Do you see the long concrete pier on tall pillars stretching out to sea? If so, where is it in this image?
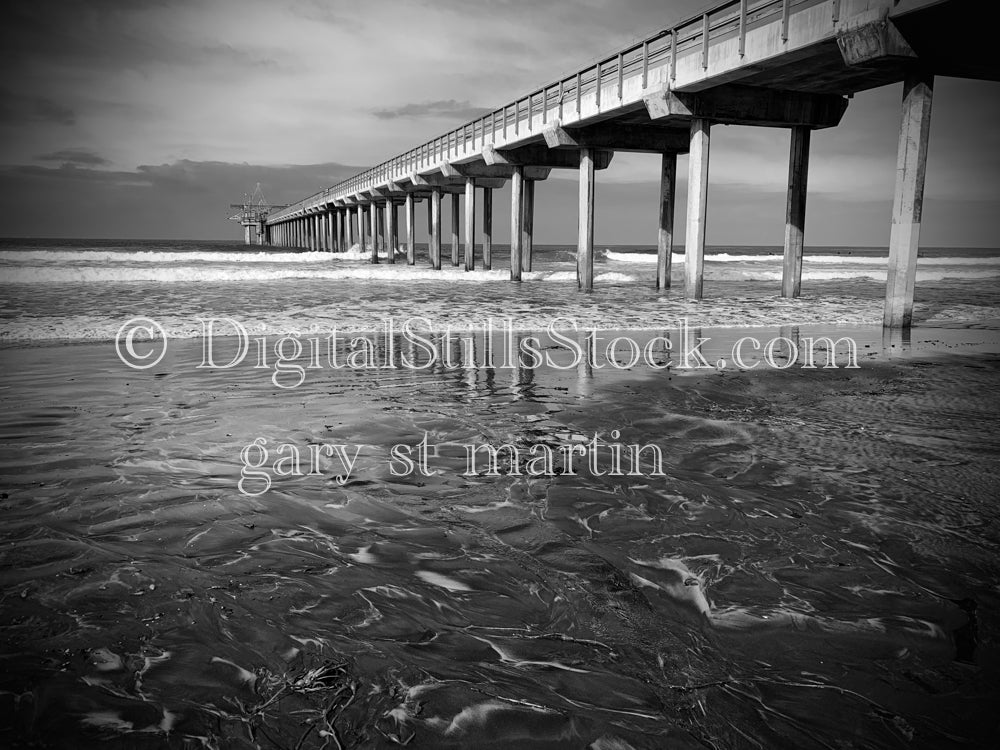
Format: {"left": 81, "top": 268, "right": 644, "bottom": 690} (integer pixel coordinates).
{"left": 259, "top": 0, "right": 1000, "bottom": 328}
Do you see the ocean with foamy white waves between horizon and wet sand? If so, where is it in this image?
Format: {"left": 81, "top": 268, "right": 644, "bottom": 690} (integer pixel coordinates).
{"left": 0, "top": 240, "right": 1000, "bottom": 343}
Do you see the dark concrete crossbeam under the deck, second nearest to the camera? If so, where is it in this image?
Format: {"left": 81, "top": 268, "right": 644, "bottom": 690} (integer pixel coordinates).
{"left": 643, "top": 84, "right": 847, "bottom": 129}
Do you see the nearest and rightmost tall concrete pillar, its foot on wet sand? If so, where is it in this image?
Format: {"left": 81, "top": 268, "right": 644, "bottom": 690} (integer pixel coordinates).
{"left": 882, "top": 70, "right": 934, "bottom": 328}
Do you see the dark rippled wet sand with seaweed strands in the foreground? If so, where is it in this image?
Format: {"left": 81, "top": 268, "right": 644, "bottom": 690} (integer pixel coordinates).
{"left": 0, "top": 326, "right": 1000, "bottom": 750}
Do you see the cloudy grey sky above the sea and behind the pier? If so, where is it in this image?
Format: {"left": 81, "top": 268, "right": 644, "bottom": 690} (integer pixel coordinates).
{"left": 0, "top": 0, "right": 1000, "bottom": 247}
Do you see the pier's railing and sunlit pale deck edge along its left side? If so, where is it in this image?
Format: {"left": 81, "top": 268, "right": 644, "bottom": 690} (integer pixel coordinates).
{"left": 268, "top": 0, "right": 841, "bottom": 223}
